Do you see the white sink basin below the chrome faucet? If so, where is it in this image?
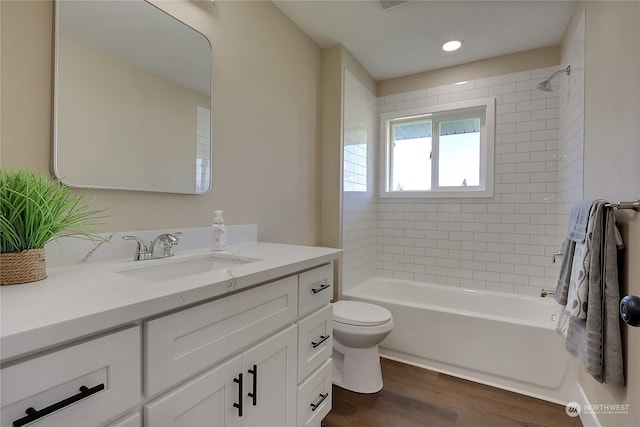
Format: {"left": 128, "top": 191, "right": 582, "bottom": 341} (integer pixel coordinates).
{"left": 118, "top": 254, "right": 259, "bottom": 282}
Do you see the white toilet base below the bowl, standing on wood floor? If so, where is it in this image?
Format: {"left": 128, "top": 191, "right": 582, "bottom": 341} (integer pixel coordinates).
{"left": 332, "top": 339, "right": 382, "bottom": 393}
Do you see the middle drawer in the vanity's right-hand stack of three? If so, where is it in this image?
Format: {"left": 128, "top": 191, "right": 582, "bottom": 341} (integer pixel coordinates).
{"left": 298, "top": 304, "right": 333, "bottom": 382}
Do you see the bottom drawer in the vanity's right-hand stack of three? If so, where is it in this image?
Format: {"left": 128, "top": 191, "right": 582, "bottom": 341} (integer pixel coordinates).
{"left": 297, "top": 359, "right": 333, "bottom": 427}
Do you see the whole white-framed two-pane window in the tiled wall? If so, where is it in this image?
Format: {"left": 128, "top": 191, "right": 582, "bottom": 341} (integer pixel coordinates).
{"left": 380, "top": 98, "right": 495, "bottom": 197}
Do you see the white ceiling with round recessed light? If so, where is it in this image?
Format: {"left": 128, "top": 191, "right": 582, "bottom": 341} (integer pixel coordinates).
{"left": 273, "top": 0, "right": 576, "bottom": 80}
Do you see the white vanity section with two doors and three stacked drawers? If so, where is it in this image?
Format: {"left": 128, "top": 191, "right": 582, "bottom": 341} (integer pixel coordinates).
{"left": 144, "top": 264, "right": 333, "bottom": 427}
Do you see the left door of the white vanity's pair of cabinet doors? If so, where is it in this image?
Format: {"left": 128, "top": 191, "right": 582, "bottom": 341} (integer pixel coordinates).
{"left": 144, "top": 356, "right": 242, "bottom": 427}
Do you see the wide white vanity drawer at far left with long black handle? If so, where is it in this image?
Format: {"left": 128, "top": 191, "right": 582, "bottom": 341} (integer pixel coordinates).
{"left": 0, "top": 327, "right": 140, "bottom": 427}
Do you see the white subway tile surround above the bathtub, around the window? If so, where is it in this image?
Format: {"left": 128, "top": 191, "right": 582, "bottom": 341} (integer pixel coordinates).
{"left": 343, "top": 66, "right": 583, "bottom": 295}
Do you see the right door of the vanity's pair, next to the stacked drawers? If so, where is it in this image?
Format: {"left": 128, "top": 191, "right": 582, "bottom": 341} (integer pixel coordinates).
{"left": 242, "top": 325, "right": 297, "bottom": 427}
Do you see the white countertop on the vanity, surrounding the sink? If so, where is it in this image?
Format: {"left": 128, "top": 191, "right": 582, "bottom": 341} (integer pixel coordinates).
{"left": 0, "top": 243, "right": 341, "bottom": 361}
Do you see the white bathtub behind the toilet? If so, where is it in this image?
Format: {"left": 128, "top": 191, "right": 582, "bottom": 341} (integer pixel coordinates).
{"left": 342, "top": 278, "right": 578, "bottom": 404}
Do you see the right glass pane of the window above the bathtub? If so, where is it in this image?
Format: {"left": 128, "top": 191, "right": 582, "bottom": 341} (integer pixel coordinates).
{"left": 438, "top": 118, "right": 480, "bottom": 187}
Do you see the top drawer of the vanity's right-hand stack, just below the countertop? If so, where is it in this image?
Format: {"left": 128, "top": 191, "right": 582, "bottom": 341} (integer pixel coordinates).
{"left": 298, "top": 264, "right": 333, "bottom": 317}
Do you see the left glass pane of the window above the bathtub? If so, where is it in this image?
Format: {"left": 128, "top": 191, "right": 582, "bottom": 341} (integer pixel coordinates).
{"left": 389, "top": 121, "right": 431, "bottom": 191}
